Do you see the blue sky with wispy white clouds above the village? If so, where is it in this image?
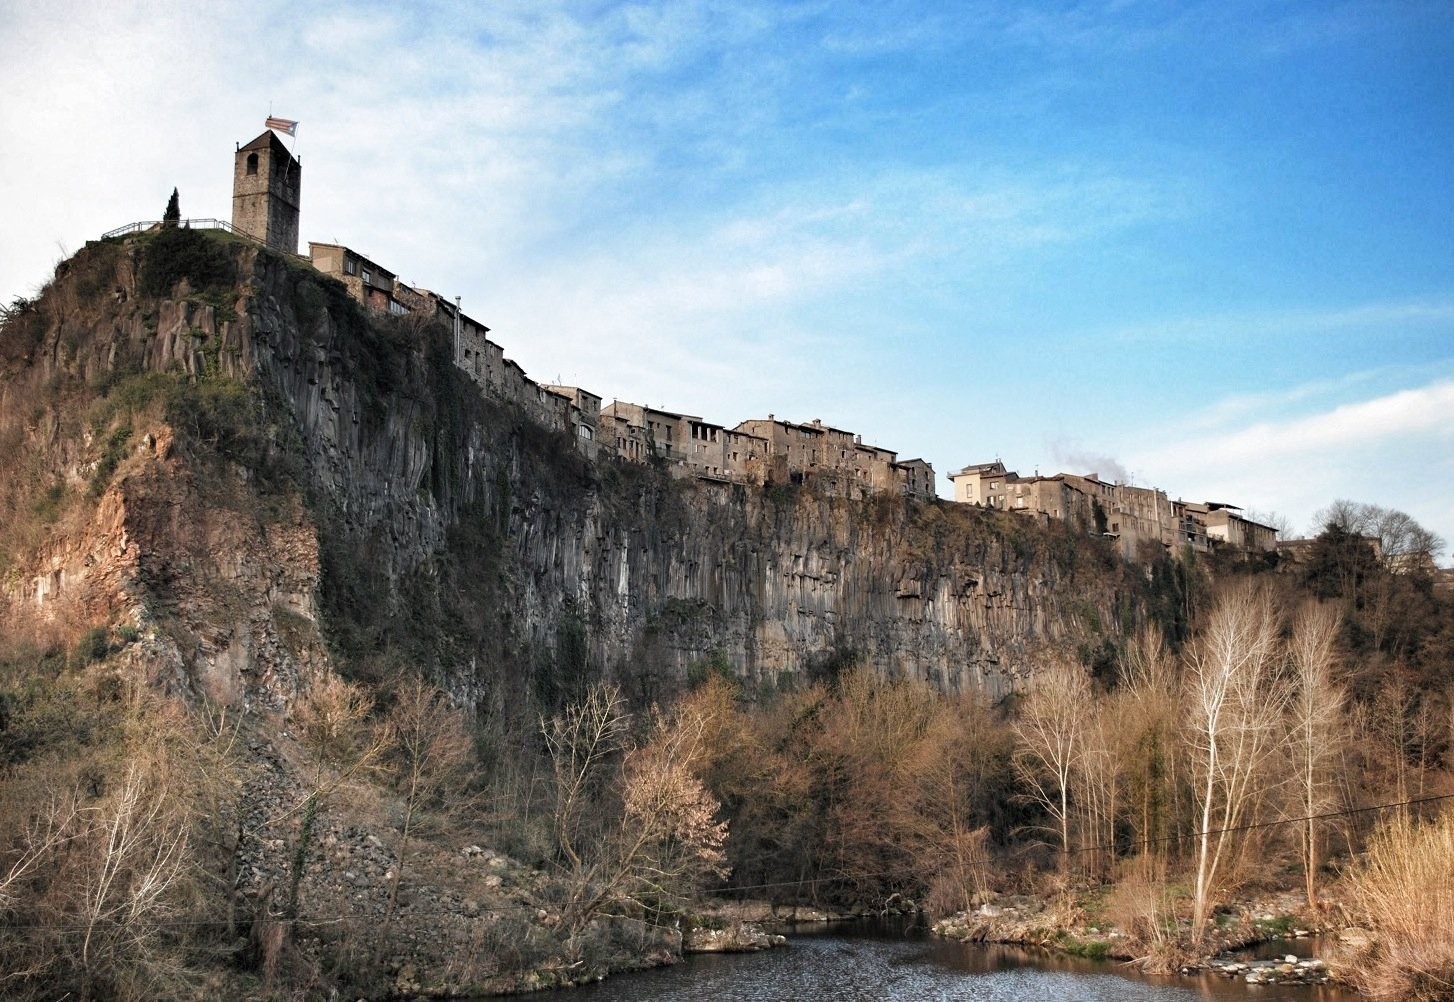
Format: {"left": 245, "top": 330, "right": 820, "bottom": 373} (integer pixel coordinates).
{"left": 8, "top": 0, "right": 1454, "bottom": 564}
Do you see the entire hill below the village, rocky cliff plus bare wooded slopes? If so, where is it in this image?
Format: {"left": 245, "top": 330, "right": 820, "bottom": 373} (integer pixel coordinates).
{"left": 0, "top": 230, "right": 1454, "bottom": 999}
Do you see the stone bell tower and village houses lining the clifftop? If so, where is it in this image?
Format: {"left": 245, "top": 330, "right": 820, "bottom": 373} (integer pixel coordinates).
{"left": 223, "top": 129, "right": 1277, "bottom": 560}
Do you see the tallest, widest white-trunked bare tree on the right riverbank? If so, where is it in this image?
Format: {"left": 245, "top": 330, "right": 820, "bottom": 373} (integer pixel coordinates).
{"left": 1188, "top": 585, "right": 1287, "bottom": 939}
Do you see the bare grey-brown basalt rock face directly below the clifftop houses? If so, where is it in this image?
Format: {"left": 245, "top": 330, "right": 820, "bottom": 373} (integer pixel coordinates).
{"left": 0, "top": 237, "right": 1144, "bottom": 707}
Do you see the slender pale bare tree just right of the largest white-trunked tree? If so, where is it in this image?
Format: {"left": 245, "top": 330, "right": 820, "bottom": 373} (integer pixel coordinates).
{"left": 1287, "top": 604, "right": 1346, "bottom": 907}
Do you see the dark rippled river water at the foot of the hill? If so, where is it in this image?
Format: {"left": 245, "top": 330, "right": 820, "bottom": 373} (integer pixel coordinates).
{"left": 529, "top": 929, "right": 1357, "bottom": 1002}
